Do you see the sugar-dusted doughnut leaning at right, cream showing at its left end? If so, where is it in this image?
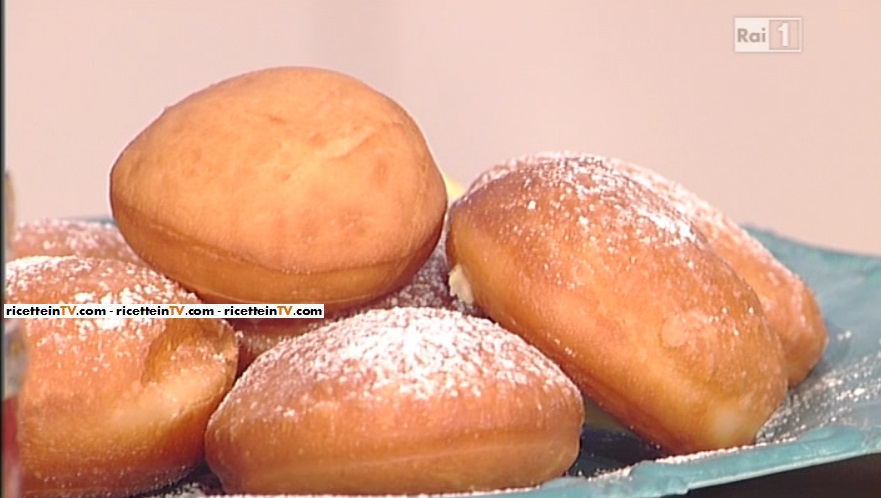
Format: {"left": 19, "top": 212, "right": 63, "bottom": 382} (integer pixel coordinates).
{"left": 447, "top": 156, "right": 786, "bottom": 453}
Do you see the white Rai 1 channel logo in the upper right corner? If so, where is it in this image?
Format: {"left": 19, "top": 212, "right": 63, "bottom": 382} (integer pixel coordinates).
{"left": 734, "top": 17, "right": 803, "bottom": 53}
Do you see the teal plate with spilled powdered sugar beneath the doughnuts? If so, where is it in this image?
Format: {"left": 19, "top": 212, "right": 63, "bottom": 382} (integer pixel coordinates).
{"left": 141, "top": 229, "right": 881, "bottom": 498}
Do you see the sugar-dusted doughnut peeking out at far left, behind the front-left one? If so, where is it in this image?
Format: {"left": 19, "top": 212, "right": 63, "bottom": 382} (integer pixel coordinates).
{"left": 10, "top": 218, "right": 144, "bottom": 265}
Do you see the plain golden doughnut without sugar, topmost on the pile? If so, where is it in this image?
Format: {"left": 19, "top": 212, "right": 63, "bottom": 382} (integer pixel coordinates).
{"left": 110, "top": 67, "right": 447, "bottom": 311}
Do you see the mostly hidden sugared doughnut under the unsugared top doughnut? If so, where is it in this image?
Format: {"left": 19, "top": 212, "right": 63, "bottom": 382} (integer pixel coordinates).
{"left": 229, "top": 246, "right": 484, "bottom": 370}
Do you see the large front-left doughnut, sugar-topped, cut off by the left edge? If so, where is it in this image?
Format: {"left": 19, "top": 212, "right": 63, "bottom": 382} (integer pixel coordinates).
{"left": 6, "top": 256, "right": 238, "bottom": 498}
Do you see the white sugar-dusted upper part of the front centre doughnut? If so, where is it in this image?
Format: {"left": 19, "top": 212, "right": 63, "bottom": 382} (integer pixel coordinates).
{"left": 230, "top": 308, "right": 577, "bottom": 408}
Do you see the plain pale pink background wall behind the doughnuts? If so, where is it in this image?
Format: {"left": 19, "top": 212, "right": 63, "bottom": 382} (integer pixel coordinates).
{"left": 4, "top": 0, "right": 881, "bottom": 255}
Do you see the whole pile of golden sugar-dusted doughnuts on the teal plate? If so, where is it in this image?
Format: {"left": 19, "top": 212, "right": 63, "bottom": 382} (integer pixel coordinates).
{"left": 6, "top": 67, "right": 826, "bottom": 497}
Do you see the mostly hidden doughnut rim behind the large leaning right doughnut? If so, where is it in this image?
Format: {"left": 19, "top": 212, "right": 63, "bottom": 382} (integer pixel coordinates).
{"left": 471, "top": 152, "right": 828, "bottom": 386}
